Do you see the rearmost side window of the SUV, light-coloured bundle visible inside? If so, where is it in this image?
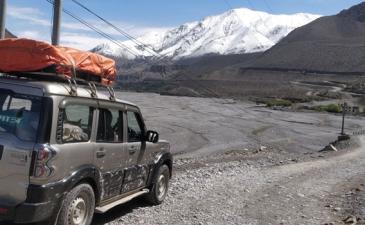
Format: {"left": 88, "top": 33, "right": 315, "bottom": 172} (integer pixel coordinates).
{"left": 62, "top": 105, "right": 94, "bottom": 143}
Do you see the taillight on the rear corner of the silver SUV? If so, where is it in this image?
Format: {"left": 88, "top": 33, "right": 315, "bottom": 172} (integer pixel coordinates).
{"left": 33, "top": 145, "right": 56, "bottom": 178}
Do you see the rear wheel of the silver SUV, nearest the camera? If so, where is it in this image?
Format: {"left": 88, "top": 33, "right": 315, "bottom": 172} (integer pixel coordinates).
{"left": 55, "top": 184, "right": 95, "bottom": 225}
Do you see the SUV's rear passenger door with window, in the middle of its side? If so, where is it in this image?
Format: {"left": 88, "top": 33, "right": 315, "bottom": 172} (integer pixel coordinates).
{"left": 95, "top": 105, "right": 126, "bottom": 200}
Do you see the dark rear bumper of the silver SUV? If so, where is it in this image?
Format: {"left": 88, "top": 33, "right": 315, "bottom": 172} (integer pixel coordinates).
{"left": 0, "top": 202, "right": 56, "bottom": 224}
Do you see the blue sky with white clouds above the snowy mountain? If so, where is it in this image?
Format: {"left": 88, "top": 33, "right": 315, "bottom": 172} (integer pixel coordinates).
{"left": 6, "top": 0, "right": 362, "bottom": 49}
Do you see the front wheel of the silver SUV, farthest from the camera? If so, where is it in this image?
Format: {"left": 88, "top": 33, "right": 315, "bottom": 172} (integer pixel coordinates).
{"left": 146, "top": 165, "right": 170, "bottom": 205}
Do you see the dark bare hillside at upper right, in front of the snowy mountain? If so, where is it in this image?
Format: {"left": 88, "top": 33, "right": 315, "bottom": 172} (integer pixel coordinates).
{"left": 247, "top": 2, "right": 365, "bottom": 72}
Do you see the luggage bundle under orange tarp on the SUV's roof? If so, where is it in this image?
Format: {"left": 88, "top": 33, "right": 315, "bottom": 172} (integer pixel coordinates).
{"left": 0, "top": 38, "right": 116, "bottom": 86}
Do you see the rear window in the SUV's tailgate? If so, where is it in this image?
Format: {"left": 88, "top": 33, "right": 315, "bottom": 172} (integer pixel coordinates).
{"left": 0, "top": 89, "right": 42, "bottom": 141}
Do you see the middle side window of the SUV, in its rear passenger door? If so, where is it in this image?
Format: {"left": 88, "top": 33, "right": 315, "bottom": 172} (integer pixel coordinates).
{"left": 96, "top": 109, "right": 123, "bottom": 142}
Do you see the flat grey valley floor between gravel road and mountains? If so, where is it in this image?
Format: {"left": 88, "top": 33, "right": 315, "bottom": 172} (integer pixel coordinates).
{"left": 117, "top": 92, "right": 365, "bottom": 158}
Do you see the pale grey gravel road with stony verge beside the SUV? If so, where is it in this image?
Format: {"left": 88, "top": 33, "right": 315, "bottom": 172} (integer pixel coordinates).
{"left": 93, "top": 138, "right": 365, "bottom": 225}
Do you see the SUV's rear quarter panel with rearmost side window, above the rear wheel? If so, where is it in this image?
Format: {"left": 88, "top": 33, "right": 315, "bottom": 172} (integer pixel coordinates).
{"left": 50, "top": 101, "right": 97, "bottom": 182}
